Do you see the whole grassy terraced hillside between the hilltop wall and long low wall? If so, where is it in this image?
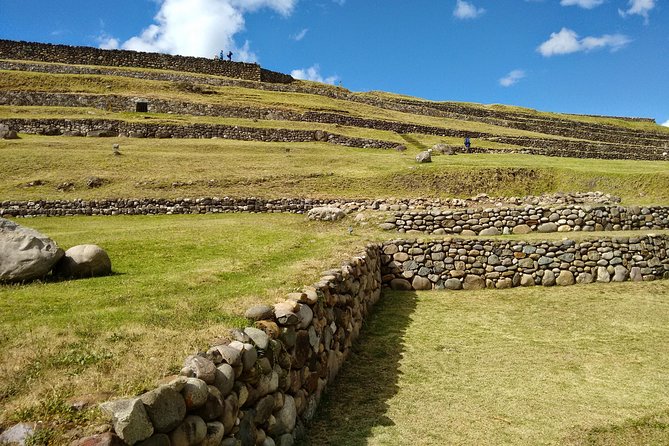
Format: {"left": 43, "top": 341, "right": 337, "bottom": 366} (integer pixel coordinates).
{"left": 0, "top": 52, "right": 669, "bottom": 203}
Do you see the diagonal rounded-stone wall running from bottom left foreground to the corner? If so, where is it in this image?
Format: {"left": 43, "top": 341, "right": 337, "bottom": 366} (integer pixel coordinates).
{"left": 97, "top": 245, "right": 381, "bottom": 446}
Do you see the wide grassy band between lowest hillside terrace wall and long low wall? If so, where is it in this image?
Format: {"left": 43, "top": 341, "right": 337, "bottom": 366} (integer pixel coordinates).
{"left": 0, "top": 135, "right": 669, "bottom": 204}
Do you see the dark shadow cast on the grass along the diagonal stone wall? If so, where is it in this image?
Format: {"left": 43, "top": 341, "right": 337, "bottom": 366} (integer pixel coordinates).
{"left": 298, "top": 292, "right": 417, "bottom": 446}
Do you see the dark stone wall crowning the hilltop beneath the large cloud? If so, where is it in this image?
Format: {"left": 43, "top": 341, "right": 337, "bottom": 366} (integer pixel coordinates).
{"left": 0, "top": 39, "right": 293, "bottom": 83}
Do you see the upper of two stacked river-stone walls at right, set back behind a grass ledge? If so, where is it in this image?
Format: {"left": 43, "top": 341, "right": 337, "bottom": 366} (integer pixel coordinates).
{"left": 381, "top": 205, "right": 669, "bottom": 236}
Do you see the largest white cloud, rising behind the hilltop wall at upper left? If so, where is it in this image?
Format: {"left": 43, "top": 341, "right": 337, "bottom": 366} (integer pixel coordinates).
{"left": 100, "top": 0, "right": 298, "bottom": 62}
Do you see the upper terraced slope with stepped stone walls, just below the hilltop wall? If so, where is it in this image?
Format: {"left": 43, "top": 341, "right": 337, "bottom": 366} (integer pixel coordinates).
{"left": 0, "top": 56, "right": 669, "bottom": 160}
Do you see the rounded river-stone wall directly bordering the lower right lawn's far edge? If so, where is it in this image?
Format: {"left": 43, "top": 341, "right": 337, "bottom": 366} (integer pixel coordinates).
{"left": 383, "top": 235, "right": 669, "bottom": 290}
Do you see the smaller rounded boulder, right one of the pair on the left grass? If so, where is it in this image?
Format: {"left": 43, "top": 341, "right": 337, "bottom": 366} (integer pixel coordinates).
{"left": 53, "top": 245, "right": 111, "bottom": 278}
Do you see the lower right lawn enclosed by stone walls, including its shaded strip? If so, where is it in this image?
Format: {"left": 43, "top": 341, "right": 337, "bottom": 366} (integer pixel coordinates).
{"left": 302, "top": 282, "right": 669, "bottom": 446}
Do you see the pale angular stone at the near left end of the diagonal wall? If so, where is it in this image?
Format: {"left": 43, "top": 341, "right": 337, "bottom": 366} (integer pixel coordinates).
{"left": 100, "top": 398, "right": 153, "bottom": 445}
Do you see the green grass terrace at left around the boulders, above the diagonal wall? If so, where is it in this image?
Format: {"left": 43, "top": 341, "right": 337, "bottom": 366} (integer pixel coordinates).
{"left": 0, "top": 214, "right": 368, "bottom": 440}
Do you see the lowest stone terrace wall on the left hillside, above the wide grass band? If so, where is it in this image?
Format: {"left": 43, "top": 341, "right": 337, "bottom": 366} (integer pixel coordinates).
{"left": 0, "top": 118, "right": 397, "bottom": 149}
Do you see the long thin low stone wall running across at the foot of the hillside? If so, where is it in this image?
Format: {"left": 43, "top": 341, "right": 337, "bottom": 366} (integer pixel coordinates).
{"left": 0, "top": 192, "right": 620, "bottom": 217}
